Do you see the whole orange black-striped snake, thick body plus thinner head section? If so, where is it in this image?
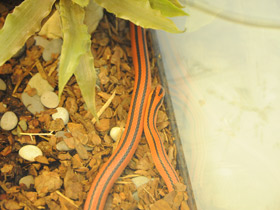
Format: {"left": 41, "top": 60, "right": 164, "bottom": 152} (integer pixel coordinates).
{"left": 84, "top": 23, "right": 178, "bottom": 210}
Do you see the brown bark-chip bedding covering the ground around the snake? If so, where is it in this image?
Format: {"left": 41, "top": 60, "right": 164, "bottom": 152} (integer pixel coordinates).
{"left": 0, "top": 2, "right": 189, "bottom": 210}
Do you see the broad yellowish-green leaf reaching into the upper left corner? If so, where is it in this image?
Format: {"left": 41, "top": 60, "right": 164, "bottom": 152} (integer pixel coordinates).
{"left": 0, "top": 0, "right": 55, "bottom": 66}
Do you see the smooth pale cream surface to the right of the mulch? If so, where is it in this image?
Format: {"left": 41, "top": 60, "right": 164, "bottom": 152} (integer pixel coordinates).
{"left": 155, "top": 0, "right": 280, "bottom": 210}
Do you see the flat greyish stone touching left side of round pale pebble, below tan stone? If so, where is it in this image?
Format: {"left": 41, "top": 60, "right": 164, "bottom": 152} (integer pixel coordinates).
{"left": 21, "top": 92, "right": 45, "bottom": 114}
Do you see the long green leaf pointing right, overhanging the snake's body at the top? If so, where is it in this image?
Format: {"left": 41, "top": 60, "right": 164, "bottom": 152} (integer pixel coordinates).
{"left": 95, "top": 0, "right": 183, "bottom": 33}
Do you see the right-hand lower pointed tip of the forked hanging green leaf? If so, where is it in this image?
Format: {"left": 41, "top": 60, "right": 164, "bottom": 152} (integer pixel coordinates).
{"left": 75, "top": 52, "right": 98, "bottom": 120}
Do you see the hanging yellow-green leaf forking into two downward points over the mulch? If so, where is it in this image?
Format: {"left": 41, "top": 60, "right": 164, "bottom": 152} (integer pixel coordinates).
{"left": 59, "top": 0, "right": 99, "bottom": 116}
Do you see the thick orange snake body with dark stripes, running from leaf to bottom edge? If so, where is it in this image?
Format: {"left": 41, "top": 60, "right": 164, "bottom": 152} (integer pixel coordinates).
{"left": 84, "top": 23, "right": 151, "bottom": 210}
